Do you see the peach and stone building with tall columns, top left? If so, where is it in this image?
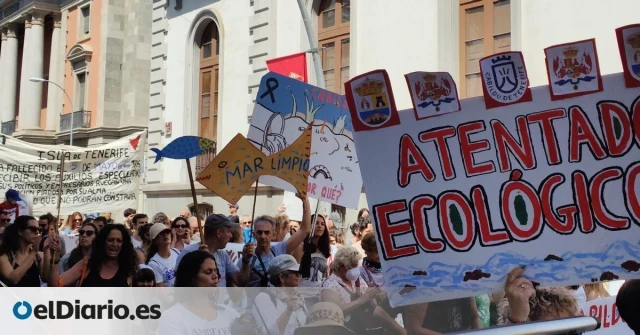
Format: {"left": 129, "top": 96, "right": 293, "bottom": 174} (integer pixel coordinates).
{"left": 0, "top": 0, "right": 152, "bottom": 146}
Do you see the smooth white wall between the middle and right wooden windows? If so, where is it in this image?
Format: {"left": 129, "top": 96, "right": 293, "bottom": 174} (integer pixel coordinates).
{"left": 351, "top": 0, "right": 440, "bottom": 109}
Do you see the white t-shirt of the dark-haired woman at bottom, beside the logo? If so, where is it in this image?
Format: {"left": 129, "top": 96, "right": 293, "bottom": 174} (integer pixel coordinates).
{"left": 156, "top": 303, "right": 238, "bottom": 335}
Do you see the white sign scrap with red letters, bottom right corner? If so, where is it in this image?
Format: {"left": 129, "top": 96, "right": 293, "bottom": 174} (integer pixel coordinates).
{"left": 580, "top": 296, "right": 634, "bottom": 335}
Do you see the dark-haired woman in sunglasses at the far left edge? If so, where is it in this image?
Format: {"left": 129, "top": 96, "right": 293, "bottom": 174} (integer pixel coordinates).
{"left": 0, "top": 215, "right": 48, "bottom": 287}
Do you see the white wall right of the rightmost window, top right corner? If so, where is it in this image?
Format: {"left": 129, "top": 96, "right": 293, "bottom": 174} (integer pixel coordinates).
{"left": 520, "top": 0, "right": 640, "bottom": 86}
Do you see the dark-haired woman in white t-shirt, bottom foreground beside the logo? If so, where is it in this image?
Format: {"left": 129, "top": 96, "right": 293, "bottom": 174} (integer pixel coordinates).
{"left": 156, "top": 250, "right": 238, "bottom": 335}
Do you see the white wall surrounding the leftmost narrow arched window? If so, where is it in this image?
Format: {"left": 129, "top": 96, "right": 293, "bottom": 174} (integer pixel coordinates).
{"left": 162, "top": 0, "right": 250, "bottom": 183}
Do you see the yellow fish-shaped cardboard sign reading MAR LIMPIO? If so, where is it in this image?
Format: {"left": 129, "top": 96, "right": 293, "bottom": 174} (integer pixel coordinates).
{"left": 196, "top": 125, "right": 311, "bottom": 204}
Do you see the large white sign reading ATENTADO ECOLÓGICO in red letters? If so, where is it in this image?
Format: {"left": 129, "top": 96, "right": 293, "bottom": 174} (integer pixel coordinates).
{"left": 352, "top": 73, "right": 640, "bottom": 306}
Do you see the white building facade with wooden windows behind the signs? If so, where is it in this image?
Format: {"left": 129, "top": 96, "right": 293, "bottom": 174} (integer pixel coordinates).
{"left": 143, "top": 0, "right": 640, "bottom": 223}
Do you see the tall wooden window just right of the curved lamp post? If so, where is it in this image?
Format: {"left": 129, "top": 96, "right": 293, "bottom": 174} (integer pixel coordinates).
{"left": 318, "top": 0, "right": 351, "bottom": 94}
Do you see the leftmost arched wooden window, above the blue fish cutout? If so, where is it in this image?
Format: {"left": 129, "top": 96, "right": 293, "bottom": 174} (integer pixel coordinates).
{"left": 198, "top": 21, "right": 220, "bottom": 142}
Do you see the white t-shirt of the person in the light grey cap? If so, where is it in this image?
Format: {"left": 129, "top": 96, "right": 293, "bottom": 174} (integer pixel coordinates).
{"left": 252, "top": 292, "right": 307, "bottom": 335}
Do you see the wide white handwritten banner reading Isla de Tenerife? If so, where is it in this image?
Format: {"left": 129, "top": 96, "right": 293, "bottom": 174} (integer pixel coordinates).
{"left": 0, "top": 132, "right": 146, "bottom": 215}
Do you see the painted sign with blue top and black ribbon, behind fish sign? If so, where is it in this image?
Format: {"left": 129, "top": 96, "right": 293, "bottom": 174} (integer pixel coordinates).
{"left": 247, "top": 73, "right": 362, "bottom": 208}
